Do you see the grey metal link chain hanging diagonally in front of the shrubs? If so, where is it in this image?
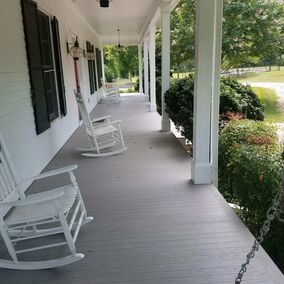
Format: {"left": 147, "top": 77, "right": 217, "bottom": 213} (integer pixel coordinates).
{"left": 235, "top": 169, "right": 284, "bottom": 284}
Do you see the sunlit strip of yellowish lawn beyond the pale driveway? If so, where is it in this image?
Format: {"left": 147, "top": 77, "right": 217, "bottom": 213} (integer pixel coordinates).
{"left": 237, "top": 70, "right": 284, "bottom": 83}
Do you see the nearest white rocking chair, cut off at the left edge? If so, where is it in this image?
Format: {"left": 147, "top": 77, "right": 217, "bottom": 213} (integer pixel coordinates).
{"left": 0, "top": 135, "right": 93, "bottom": 270}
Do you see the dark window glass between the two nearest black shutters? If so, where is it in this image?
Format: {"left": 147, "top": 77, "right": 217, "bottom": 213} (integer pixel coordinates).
{"left": 37, "top": 11, "right": 59, "bottom": 122}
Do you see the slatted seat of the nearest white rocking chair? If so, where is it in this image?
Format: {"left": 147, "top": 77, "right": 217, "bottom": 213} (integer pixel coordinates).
{"left": 5, "top": 185, "right": 77, "bottom": 225}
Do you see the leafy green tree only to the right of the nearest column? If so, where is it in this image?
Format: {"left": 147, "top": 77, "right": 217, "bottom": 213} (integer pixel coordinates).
{"left": 222, "top": 0, "right": 284, "bottom": 69}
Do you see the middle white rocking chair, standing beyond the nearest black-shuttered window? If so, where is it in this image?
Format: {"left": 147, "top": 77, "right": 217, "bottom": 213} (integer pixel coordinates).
{"left": 74, "top": 91, "right": 127, "bottom": 157}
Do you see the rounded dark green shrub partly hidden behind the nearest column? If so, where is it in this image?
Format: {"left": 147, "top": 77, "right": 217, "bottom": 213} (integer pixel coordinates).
{"left": 165, "top": 76, "right": 264, "bottom": 140}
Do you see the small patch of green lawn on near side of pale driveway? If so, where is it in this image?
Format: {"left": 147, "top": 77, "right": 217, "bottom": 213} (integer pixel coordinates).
{"left": 252, "top": 87, "right": 284, "bottom": 122}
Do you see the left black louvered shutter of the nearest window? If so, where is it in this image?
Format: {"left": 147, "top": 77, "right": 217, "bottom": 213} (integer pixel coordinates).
{"left": 21, "top": 0, "right": 50, "bottom": 134}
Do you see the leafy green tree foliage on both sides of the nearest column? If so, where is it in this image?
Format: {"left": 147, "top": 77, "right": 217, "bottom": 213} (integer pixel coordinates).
{"left": 171, "top": 0, "right": 284, "bottom": 71}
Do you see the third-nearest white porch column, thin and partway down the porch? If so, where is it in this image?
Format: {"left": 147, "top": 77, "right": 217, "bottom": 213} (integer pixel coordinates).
{"left": 149, "top": 25, "right": 157, "bottom": 111}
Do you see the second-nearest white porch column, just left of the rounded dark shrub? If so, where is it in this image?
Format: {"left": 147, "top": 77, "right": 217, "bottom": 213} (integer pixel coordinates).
{"left": 161, "top": 2, "right": 171, "bottom": 131}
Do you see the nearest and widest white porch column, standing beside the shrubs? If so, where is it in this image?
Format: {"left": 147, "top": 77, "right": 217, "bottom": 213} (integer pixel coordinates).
{"left": 192, "top": 0, "right": 223, "bottom": 184}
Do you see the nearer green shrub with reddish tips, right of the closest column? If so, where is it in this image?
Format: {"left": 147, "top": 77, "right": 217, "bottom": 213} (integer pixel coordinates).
{"left": 219, "top": 120, "right": 281, "bottom": 204}
